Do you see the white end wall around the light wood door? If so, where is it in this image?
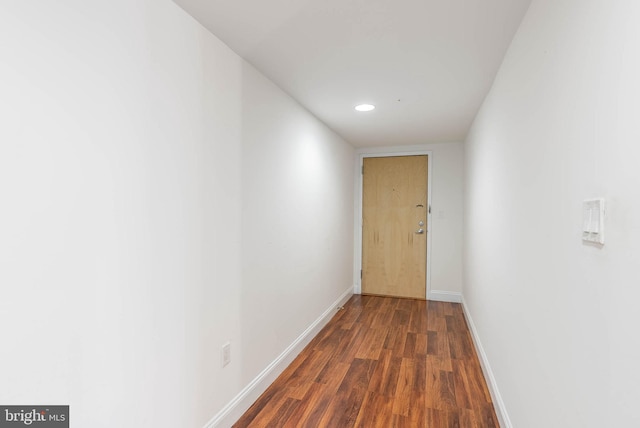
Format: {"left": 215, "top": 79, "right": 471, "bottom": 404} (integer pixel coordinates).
{"left": 354, "top": 143, "right": 464, "bottom": 300}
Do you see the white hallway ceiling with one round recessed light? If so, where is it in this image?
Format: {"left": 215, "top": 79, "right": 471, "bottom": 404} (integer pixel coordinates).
{"left": 174, "top": 0, "right": 531, "bottom": 147}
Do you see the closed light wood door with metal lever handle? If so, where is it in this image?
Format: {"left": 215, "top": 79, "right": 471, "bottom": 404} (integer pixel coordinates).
{"left": 362, "top": 155, "right": 428, "bottom": 299}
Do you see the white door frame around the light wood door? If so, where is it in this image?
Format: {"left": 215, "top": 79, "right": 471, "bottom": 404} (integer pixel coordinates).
{"left": 353, "top": 148, "right": 433, "bottom": 299}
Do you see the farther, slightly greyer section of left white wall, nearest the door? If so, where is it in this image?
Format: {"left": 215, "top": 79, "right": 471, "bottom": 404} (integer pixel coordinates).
{"left": 241, "top": 65, "right": 355, "bottom": 382}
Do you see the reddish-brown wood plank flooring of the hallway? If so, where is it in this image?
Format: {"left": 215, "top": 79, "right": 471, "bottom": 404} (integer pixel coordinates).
{"left": 234, "top": 295, "right": 498, "bottom": 428}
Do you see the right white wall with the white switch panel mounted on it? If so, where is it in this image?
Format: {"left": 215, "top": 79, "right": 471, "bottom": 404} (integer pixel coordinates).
{"left": 463, "top": 0, "right": 640, "bottom": 428}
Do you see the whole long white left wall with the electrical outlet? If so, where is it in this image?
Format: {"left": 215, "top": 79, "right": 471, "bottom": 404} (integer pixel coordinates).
{"left": 0, "top": 0, "right": 354, "bottom": 428}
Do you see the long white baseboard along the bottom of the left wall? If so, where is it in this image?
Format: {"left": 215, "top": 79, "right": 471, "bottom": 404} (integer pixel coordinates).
{"left": 204, "top": 286, "right": 353, "bottom": 428}
